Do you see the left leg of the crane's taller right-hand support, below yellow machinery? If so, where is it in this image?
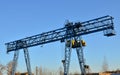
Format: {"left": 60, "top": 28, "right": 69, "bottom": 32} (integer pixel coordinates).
{"left": 63, "top": 40, "right": 72, "bottom": 75}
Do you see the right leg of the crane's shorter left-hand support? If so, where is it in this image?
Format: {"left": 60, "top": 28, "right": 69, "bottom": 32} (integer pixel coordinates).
{"left": 24, "top": 48, "right": 32, "bottom": 75}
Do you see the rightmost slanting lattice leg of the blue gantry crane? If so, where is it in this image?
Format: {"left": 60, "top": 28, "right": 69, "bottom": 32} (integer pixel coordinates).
{"left": 76, "top": 37, "right": 86, "bottom": 75}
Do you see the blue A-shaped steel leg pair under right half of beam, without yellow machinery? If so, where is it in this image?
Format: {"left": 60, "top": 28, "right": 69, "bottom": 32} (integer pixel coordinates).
{"left": 63, "top": 37, "right": 86, "bottom": 75}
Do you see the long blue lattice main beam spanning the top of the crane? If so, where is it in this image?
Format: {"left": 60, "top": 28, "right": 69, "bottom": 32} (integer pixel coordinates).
{"left": 6, "top": 15, "right": 115, "bottom": 53}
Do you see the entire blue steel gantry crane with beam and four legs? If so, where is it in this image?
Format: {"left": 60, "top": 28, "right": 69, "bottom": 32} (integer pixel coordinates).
{"left": 5, "top": 15, "right": 115, "bottom": 75}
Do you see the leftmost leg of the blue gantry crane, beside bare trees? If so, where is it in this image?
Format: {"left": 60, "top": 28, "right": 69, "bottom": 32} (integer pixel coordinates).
{"left": 11, "top": 50, "right": 19, "bottom": 75}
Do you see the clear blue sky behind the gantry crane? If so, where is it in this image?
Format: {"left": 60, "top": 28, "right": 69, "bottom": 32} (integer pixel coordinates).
{"left": 0, "top": 0, "right": 120, "bottom": 72}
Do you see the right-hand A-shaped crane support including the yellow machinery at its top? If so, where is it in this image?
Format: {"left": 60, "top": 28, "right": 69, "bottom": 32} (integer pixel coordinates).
{"left": 62, "top": 37, "right": 86, "bottom": 75}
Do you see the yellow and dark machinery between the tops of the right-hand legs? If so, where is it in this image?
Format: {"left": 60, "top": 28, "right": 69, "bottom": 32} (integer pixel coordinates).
{"left": 66, "top": 40, "right": 86, "bottom": 48}
